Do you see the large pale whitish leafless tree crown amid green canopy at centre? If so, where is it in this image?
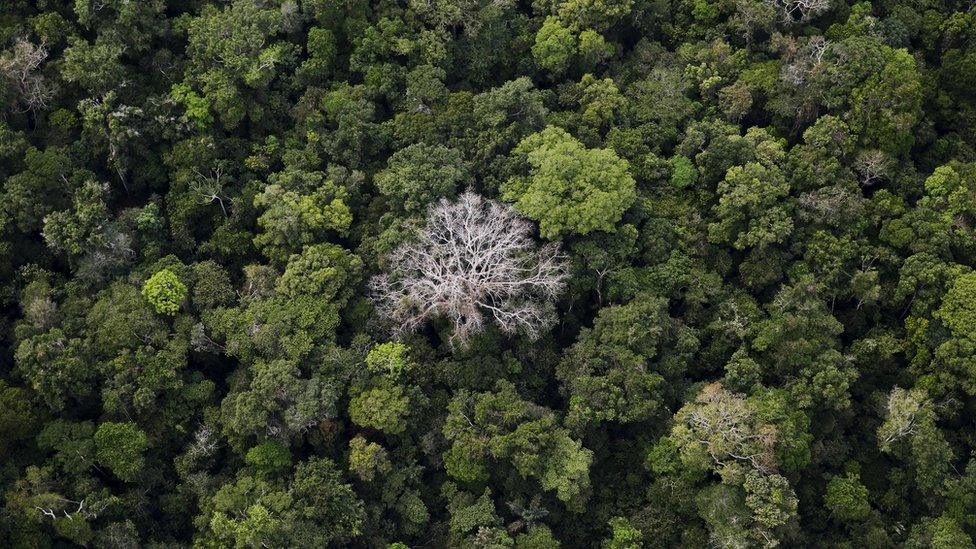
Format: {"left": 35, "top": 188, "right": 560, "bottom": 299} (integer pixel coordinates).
{"left": 371, "top": 192, "right": 568, "bottom": 345}
